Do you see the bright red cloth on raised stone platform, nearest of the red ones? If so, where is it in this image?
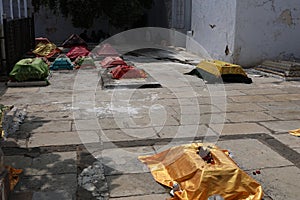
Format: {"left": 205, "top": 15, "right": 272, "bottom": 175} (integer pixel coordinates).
{"left": 111, "top": 65, "right": 147, "bottom": 79}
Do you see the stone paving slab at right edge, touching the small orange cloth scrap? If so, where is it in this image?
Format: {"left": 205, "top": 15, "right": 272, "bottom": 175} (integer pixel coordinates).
{"left": 260, "top": 120, "right": 300, "bottom": 133}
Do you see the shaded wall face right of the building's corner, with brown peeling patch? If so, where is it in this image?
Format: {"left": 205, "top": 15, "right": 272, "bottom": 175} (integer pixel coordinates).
{"left": 233, "top": 0, "right": 300, "bottom": 66}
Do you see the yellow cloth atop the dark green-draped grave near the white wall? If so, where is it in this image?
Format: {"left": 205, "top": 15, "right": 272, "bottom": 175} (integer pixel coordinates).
{"left": 197, "top": 60, "right": 247, "bottom": 77}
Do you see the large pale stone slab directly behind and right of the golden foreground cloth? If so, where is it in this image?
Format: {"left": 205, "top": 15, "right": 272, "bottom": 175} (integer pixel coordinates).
{"left": 217, "top": 139, "right": 293, "bottom": 170}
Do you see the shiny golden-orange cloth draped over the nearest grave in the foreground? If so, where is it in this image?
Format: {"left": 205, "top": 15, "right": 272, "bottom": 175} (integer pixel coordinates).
{"left": 139, "top": 143, "right": 263, "bottom": 200}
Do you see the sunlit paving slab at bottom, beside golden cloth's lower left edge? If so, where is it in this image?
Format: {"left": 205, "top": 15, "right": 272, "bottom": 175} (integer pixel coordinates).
{"left": 107, "top": 173, "right": 168, "bottom": 198}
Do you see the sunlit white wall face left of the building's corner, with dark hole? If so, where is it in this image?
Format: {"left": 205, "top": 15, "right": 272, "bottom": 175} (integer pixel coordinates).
{"left": 187, "top": 0, "right": 236, "bottom": 62}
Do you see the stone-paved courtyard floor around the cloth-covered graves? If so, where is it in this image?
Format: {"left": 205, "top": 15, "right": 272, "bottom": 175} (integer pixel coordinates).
{"left": 0, "top": 48, "right": 300, "bottom": 200}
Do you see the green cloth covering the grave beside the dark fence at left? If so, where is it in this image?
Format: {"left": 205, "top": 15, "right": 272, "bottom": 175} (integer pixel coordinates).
{"left": 9, "top": 58, "right": 49, "bottom": 82}
